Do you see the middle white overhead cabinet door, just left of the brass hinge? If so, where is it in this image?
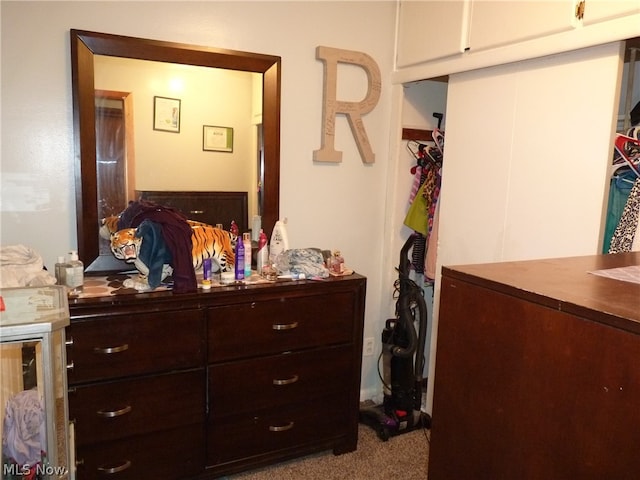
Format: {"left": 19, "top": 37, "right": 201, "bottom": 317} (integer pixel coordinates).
{"left": 469, "top": 0, "right": 578, "bottom": 53}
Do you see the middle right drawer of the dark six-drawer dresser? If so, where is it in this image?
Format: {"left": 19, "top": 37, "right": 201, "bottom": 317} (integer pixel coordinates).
{"left": 208, "top": 345, "right": 353, "bottom": 418}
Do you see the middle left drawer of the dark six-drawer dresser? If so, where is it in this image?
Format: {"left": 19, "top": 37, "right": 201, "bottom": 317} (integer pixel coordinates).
{"left": 69, "top": 369, "right": 205, "bottom": 445}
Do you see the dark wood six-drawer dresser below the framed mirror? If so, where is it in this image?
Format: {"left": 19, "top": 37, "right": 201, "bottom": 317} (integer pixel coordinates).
{"left": 67, "top": 274, "right": 366, "bottom": 480}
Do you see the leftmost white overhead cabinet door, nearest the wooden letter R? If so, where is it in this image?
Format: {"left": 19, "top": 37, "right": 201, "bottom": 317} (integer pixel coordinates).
{"left": 396, "top": 0, "right": 470, "bottom": 68}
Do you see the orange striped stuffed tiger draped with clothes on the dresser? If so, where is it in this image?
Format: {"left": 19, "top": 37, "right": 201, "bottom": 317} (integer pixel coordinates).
{"left": 100, "top": 215, "right": 238, "bottom": 291}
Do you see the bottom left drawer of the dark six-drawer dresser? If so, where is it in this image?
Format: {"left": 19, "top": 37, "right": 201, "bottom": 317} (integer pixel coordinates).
{"left": 76, "top": 425, "right": 205, "bottom": 480}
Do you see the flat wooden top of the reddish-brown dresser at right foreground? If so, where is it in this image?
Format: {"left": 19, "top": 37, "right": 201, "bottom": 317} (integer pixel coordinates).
{"left": 442, "top": 252, "right": 640, "bottom": 334}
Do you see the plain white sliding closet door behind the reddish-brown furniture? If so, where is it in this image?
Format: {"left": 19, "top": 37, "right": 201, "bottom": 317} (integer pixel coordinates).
{"left": 427, "top": 43, "right": 621, "bottom": 414}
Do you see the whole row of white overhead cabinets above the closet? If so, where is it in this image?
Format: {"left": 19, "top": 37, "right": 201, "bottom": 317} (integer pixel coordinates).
{"left": 396, "top": 0, "right": 640, "bottom": 78}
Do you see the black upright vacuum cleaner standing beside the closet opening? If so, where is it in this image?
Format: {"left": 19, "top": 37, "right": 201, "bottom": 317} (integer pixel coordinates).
{"left": 360, "top": 234, "right": 431, "bottom": 441}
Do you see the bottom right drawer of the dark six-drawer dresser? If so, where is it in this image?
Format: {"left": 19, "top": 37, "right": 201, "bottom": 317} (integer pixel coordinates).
{"left": 207, "top": 395, "right": 353, "bottom": 465}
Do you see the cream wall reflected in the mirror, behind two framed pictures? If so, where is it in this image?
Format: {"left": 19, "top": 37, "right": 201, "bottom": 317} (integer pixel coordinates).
{"left": 94, "top": 55, "right": 262, "bottom": 195}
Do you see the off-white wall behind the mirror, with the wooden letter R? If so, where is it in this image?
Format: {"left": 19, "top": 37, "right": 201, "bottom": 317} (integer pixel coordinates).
{"left": 0, "top": 1, "right": 395, "bottom": 400}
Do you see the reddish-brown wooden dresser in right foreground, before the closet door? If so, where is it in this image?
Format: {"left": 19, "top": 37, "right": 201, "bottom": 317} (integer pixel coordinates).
{"left": 429, "top": 252, "right": 640, "bottom": 480}
